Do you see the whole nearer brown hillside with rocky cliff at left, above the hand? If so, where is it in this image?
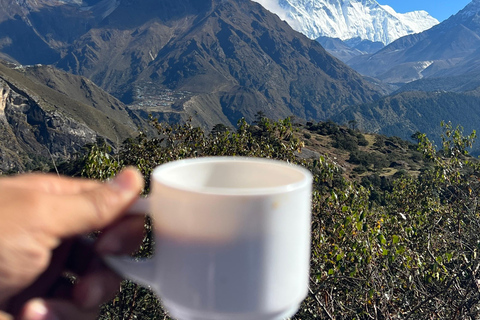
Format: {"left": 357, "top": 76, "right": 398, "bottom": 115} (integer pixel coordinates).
{"left": 0, "top": 63, "right": 141, "bottom": 172}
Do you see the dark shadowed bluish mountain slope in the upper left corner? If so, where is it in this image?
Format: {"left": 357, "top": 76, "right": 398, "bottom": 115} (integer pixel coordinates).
{"left": 0, "top": 0, "right": 119, "bottom": 65}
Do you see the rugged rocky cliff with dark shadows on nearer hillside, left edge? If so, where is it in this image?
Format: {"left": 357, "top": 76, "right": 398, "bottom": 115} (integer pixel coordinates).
{"left": 0, "top": 80, "right": 97, "bottom": 171}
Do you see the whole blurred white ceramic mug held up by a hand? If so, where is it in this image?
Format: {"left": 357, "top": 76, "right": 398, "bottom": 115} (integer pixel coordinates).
{"left": 106, "top": 157, "right": 312, "bottom": 320}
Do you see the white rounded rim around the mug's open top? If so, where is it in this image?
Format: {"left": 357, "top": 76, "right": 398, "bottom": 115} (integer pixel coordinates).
{"left": 151, "top": 156, "right": 313, "bottom": 196}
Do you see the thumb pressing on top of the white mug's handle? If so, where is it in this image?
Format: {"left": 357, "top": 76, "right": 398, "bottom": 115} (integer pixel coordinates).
{"left": 50, "top": 168, "right": 143, "bottom": 238}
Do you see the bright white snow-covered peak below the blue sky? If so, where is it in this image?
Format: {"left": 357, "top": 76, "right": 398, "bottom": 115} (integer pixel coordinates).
{"left": 256, "top": 0, "right": 439, "bottom": 45}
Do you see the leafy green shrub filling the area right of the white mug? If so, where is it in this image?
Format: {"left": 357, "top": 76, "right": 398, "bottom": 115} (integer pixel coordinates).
{"left": 299, "top": 123, "right": 480, "bottom": 319}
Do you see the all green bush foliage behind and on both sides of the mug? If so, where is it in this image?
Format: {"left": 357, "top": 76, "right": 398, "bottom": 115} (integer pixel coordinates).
{"left": 77, "top": 117, "right": 480, "bottom": 320}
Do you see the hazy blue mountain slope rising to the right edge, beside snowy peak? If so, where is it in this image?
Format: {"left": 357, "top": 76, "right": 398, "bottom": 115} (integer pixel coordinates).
{"left": 348, "top": 0, "right": 480, "bottom": 83}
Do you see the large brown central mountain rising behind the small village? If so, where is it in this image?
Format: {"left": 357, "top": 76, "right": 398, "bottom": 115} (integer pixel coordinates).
{"left": 51, "top": 0, "right": 379, "bottom": 127}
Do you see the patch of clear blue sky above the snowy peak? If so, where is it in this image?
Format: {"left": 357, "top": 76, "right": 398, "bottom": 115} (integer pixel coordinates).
{"left": 377, "top": 0, "right": 471, "bottom": 22}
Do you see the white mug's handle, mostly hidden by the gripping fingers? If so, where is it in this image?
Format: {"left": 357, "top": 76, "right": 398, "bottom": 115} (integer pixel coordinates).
{"left": 103, "top": 198, "right": 156, "bottom": 289}
